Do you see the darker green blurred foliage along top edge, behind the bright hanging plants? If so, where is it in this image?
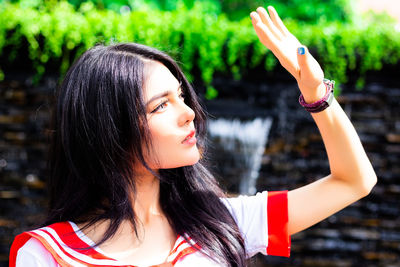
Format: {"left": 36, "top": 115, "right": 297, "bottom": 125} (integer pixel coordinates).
{"left": 47, "top": 0, "right": 354, "bottom": 23}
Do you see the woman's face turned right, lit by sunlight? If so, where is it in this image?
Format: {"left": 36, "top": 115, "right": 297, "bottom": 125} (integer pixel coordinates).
{"left": 144, "top": 62, "right": 200, "bottom": 169}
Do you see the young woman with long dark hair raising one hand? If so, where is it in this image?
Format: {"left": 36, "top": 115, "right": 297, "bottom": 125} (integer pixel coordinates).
{"left": 10, "top": 7, "right": 377, "bottom": 267}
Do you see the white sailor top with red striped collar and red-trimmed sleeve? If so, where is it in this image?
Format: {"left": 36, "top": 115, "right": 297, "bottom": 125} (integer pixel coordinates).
{"left": 9, "top": 191, "right": 290, "bottom": 267}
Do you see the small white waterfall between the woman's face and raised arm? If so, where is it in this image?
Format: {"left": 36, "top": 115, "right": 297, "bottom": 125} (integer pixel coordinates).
{"left": 209, "top": 118, "right": 272, "bottom": 195}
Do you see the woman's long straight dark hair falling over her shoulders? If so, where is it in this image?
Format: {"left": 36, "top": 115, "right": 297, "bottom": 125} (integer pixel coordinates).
{"left": 44, "top": 43, "right": 246, "bottom": 266}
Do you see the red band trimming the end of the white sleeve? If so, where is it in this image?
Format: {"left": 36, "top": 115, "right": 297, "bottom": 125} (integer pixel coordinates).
{"left": 267, "top": 191, "right": 291, "bottom": 257}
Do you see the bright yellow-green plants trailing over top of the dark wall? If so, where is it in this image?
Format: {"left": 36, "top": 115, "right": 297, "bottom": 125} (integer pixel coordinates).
{"left": 0, "top": 0, "right": 400, "bottom": 98}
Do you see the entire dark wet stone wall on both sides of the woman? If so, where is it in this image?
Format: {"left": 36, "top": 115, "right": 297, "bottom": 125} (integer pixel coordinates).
{"left": 0, "top": 69, "right": 400, "bottom": 266}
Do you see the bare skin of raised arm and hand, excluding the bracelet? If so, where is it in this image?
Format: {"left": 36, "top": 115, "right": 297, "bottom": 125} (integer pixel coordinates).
{"left": 250, "top": 6, "right": 377, "bottom": 235}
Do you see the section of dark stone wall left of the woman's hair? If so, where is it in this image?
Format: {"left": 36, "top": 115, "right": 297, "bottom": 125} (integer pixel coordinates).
{"left": 0, "top": 73, "right": 56, "bottom": 266}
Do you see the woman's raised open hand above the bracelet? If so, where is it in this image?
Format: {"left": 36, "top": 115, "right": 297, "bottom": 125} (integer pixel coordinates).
{"left": 250, "top": 6, "right": 326, "bottom": 103}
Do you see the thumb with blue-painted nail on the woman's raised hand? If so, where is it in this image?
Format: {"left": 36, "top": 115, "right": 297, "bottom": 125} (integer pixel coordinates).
{"left": 297, "top": 46, "right": 324, "bottom": 84}
